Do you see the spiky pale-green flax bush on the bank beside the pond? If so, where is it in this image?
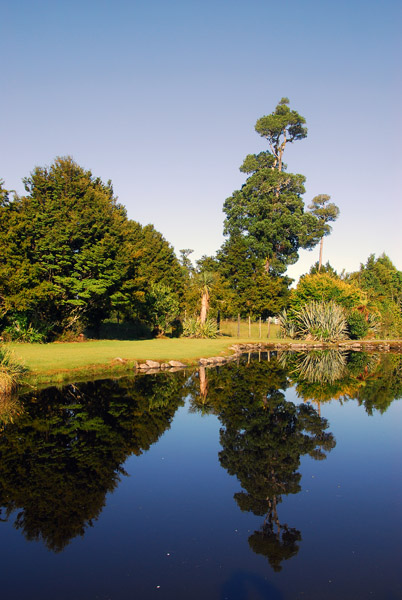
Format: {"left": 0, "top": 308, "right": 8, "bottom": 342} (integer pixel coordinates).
{"left": 280, "top": 301, "right": 348, "bottom": 341}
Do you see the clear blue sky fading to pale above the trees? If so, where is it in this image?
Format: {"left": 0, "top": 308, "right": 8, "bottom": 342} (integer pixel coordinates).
{"left": 0, "top": 0, "right": 402, "bottom": 277}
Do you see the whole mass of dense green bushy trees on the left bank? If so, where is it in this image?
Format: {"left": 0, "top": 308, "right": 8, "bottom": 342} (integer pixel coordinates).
{"left": 0, "top": 157, "right": 185, "bottom": 341}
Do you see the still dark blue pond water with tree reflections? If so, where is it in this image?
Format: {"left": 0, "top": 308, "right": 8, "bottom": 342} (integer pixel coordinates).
{"left": 0, "top": 353, "right": 402, "bottom": 600}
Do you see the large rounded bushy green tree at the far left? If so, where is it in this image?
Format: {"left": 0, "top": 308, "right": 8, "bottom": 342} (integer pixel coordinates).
{"left": 0, "top": 157, "right": 134, "bottom": 332}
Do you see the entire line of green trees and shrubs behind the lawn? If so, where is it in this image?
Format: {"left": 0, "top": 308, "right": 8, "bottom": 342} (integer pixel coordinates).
{"left": 0, "top": 98, "right": 402, "bottom": 341}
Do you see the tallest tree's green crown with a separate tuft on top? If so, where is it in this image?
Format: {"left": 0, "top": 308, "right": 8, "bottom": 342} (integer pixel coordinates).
{"left": 223, "top": 98, "right": 322, "bottom": 275}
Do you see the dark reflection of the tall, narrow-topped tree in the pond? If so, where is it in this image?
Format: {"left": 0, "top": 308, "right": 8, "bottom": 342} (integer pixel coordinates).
{"left": 204, "top": 359, "right": 335, "bottom": 571}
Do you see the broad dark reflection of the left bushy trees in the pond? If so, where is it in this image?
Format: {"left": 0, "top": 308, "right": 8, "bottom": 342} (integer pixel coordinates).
{"left": 0, "top": 374, "right": 187, "bottom": 551}
